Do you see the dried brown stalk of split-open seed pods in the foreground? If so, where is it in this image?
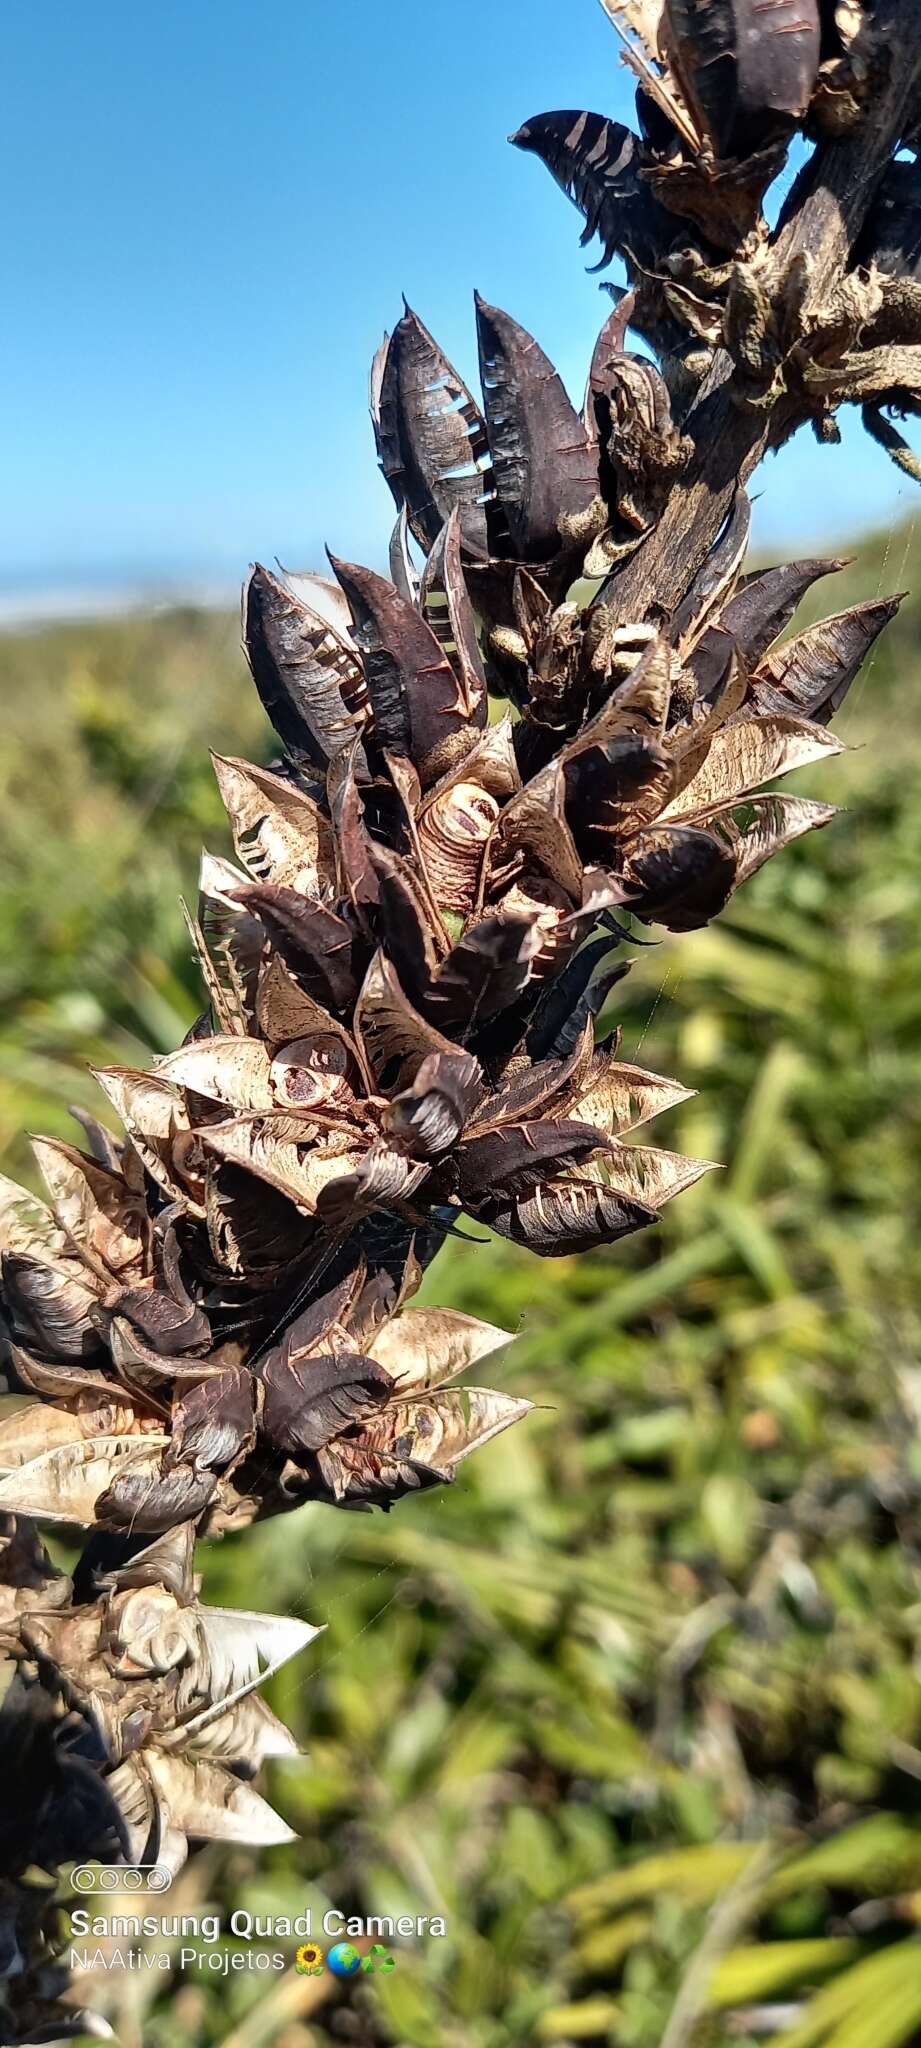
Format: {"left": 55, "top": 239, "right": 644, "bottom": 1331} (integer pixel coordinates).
{"left": 0, "top": 0, "right": 921, "bottom": 2040}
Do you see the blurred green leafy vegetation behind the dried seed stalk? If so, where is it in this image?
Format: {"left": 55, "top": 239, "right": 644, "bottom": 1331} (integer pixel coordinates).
{"left": 0, "top": 530, "right": 921, "bottom": 2048}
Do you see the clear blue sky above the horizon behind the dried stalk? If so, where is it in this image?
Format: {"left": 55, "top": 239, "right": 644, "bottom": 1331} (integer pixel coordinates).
{"left": 0, "top": 0, "right": 915, "bottom": 592}
